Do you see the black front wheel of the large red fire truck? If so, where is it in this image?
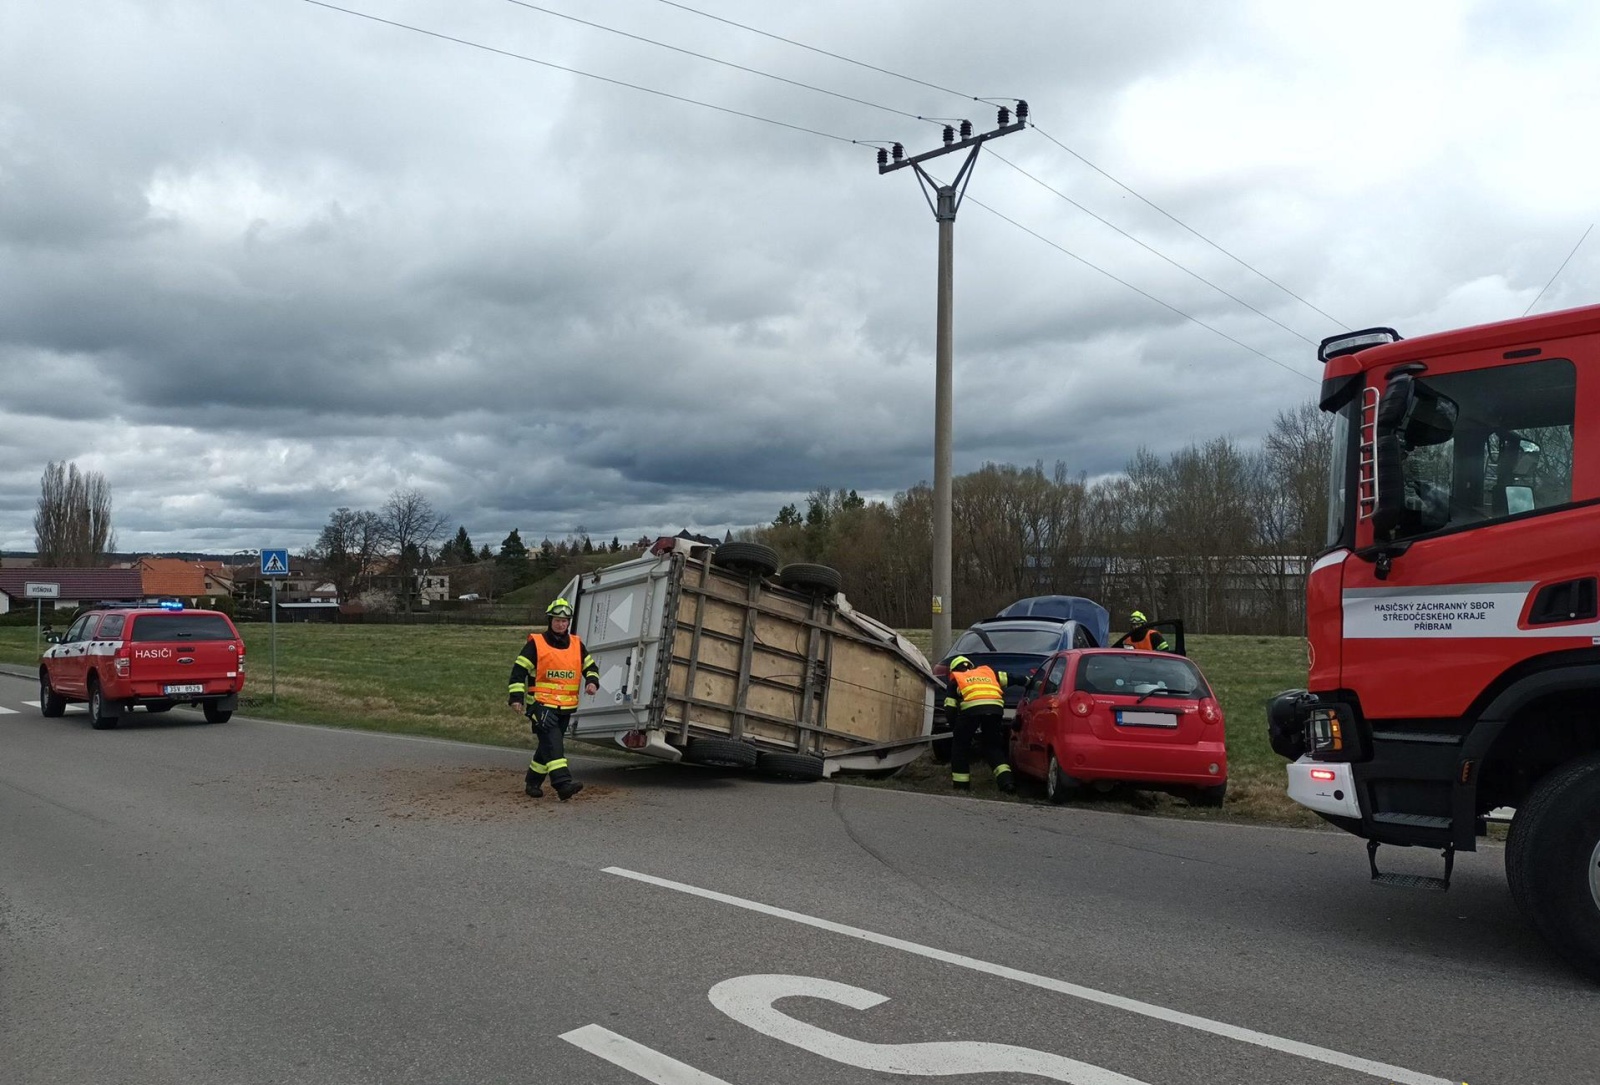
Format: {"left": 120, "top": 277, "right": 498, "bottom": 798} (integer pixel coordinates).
{"left": 1506, "top": 755, "right": 1600, "bottom": 979}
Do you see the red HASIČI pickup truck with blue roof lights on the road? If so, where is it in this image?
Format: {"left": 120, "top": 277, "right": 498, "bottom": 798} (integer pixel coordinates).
{"left": 38, "top": 603, "right": 245, "bottom": 731}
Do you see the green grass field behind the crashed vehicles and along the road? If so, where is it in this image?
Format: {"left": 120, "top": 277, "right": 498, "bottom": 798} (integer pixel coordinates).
{"left": 0, "top": 624, "right": 1322, "bottom": 826}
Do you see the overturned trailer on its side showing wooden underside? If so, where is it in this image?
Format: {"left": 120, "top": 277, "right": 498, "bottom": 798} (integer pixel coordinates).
{"left": 563, "top": 538, "right": 938, "bottom": 779}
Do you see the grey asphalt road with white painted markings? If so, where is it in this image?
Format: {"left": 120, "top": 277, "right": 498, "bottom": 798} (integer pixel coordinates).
{"left": 0, "top": 662, "right": 1600, "bottom": 1085}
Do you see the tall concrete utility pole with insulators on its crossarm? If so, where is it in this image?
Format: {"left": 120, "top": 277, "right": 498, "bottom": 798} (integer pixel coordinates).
{"left": 878, "top": 101, "right": 1027, "bottom": 659}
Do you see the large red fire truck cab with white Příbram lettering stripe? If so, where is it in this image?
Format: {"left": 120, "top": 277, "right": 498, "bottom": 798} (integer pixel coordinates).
{"left": 1267, "top": 306, "right": 1600, "bottom": 979}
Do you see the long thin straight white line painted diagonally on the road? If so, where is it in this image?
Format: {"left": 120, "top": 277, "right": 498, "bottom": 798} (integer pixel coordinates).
{"left": 603, "top": 866, "right": 1459, "bottom": 1085}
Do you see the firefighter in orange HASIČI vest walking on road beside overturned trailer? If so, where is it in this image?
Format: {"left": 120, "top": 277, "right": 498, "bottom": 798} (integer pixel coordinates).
{"left": 509, "top": 599, "right": 600, "bottom": 802}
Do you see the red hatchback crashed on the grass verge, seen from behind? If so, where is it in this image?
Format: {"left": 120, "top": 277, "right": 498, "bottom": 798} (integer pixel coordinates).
{"left": 1011, "top": 648, "right": 1227, "bottom": 807}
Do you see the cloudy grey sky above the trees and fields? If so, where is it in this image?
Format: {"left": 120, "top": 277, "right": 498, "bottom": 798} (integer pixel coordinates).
{"left": 0, "top": 0, "right": 1600, "bottom": 552}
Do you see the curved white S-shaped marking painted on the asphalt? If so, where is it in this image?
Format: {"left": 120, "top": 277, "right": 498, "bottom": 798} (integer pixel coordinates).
{"left": 709, "top": 976, "right": 1147, "bottom": 1085}
